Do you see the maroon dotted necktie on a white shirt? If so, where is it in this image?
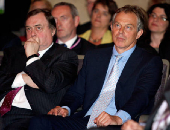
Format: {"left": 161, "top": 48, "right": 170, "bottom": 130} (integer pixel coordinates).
{"left": 0, "top": 87, "right": 22, "bottom": 116}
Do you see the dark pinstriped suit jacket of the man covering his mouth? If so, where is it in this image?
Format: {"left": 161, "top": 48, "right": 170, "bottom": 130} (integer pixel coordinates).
{"left": 0, "top": 44, "right": 78, "bottom": 114}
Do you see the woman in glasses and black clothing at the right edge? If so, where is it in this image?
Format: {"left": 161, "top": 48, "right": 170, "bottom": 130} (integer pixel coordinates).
{"left": 137, "top": 4, "right": 170, "bottom": 61}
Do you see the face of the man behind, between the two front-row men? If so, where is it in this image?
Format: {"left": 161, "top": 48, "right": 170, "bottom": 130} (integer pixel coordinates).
{"left": 52, "top": 5, "right": 79, "bottom": 42}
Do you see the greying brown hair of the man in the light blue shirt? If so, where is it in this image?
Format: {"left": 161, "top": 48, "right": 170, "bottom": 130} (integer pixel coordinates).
{"left": 112, "top": 5, "right": 148, "bottom": 31}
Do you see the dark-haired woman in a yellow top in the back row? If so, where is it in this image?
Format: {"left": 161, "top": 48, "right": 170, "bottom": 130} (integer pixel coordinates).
{"left": 80, "top": 0, "right": 117, "bottom": 46}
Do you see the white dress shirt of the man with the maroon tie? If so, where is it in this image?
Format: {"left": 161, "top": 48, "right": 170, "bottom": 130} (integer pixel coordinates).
{"left": 0, "top": 43, "right": 53, "bottom": 109}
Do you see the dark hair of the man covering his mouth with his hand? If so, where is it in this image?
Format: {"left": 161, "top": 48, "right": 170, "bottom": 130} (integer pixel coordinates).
{"left": 26, "top": 9, "right": 56, "bottom": 30}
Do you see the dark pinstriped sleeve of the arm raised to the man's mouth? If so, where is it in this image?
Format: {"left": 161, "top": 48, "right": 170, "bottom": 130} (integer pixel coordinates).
{"left": 24, "top": 50, "right": 78, "bottom": 93}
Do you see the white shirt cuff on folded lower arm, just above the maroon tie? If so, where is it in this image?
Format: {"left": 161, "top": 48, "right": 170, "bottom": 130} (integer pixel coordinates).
{"left": 11, "top": 72, "right": 25, "bottom": 88}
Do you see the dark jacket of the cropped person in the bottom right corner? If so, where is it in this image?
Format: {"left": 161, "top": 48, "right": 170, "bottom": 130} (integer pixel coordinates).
{"left": 145, "top": 80, "right": 170, "bottom": 130}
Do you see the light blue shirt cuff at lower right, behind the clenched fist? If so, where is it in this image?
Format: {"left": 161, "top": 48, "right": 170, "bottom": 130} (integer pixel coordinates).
{"left": 115, "top": 110, "right": 131, "bottom": 124}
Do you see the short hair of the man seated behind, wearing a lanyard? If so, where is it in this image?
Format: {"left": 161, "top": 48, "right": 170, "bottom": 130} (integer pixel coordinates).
{"left": 52, "top": 2, "right": 79, "bottom": 18}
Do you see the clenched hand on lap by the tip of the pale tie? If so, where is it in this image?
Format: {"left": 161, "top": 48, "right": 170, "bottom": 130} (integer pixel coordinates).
{"left": 94, "top": 111, "right": 122, "bottom": 127}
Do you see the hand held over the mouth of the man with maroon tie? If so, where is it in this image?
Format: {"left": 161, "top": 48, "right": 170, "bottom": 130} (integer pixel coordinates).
{"left": 24, "top": 36, "right": 40, "bottom": 57}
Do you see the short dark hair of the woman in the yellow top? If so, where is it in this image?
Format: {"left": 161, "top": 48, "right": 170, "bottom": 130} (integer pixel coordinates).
{"left": 92, "top": 0, "right": 118, "bottom": 21}
